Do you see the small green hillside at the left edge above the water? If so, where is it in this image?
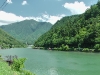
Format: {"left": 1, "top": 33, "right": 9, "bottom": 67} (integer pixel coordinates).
{"left": 0, "top": 29, "right": 24, "bottom": 49}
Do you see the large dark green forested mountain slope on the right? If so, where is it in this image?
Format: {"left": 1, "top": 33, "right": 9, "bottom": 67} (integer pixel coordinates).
{"left": 34, "top": 1, "right": 100, "bottom": 51}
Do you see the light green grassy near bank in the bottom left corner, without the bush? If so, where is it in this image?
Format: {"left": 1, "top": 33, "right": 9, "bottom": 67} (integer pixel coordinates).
{"left": 0, "top": 56, "right": 35, "bottom": 75}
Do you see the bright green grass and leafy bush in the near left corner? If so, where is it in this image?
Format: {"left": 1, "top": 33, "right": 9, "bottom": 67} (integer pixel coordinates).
{"left": 0, "top": 55, "right": 35, "bottom": 75}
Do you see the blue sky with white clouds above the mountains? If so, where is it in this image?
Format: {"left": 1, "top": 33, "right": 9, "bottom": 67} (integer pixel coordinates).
{"left": 0, "top": 0, "right": 98, "bottom": 25}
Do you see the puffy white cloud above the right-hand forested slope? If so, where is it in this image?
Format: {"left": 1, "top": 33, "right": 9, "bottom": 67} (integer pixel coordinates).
{"left": 63, "top": 1, "right": 90, "bottom": 14}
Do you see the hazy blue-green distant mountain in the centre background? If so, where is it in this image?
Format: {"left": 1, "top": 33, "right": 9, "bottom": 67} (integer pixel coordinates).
{"left": 1, "top": 20, "right": 52, "bottom": 44}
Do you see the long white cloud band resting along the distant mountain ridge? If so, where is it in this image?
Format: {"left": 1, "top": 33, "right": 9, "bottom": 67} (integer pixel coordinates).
{"left": 0, "top": 11, "right": 65, "bottom": 25}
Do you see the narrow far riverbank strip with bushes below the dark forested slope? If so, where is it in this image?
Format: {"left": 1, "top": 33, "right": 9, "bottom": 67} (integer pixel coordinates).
{"left": 32, "top": 46, "right": 100, "bottom": 53}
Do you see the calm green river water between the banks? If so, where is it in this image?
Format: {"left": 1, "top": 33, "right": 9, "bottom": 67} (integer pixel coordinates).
{"left": 0, "top": 48, "right": 100, "bottom": 75}
